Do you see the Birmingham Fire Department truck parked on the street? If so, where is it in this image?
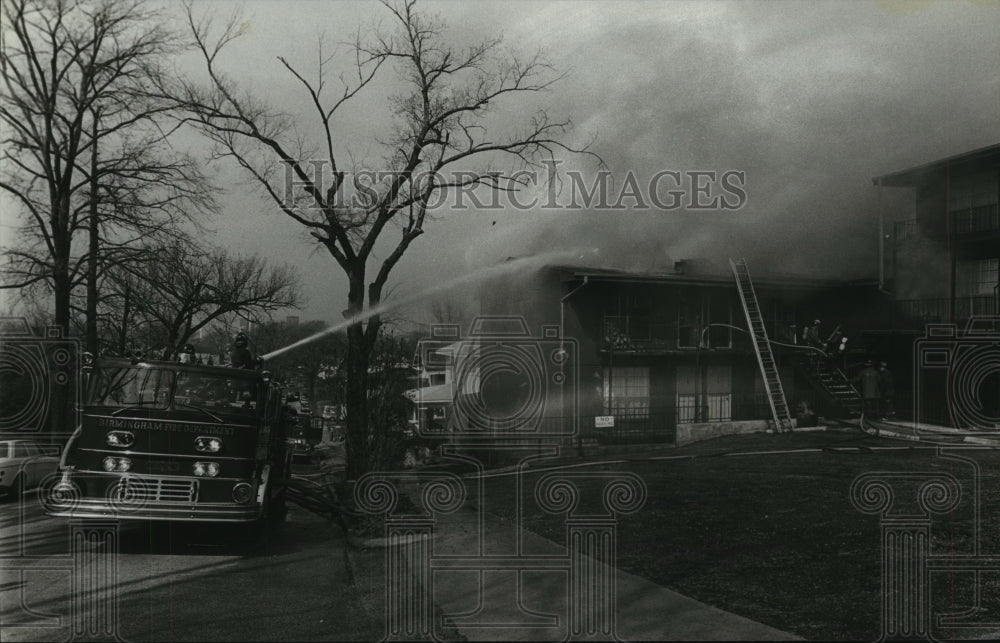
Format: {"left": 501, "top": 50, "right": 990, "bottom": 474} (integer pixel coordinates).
{"left": 43, "top": 354, "right": 291, "bottom": 528}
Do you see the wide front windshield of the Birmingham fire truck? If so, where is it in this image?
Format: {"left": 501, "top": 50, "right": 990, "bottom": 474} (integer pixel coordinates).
{"left": 89, "top": 366, "right": 257, "bottom": 412}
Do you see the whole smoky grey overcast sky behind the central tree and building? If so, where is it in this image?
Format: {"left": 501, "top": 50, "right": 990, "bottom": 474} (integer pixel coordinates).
{"left": 1, "top": 0, "right": 1000, "bottom": 330}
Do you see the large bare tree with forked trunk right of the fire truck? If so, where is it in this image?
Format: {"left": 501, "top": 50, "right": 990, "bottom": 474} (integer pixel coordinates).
{"left": 171, "top": 1, "right": 585, "bottom": 478}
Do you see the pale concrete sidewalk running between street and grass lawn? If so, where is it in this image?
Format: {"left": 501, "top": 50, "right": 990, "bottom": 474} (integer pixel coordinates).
{"left": 349, "top": 488, "right": 799, "bottom": 641}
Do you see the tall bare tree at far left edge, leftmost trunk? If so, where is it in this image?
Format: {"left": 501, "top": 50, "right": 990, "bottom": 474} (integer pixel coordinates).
{"left": 0, "top": 0, "right": 178, "bottom": 328}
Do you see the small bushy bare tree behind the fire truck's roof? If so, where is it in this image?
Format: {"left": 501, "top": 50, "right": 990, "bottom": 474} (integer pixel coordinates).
{"left": 115, "top": 242, "right": 300, "bottom": 357}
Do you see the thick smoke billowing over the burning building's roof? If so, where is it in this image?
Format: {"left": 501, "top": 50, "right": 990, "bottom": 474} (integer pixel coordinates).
{"left": 426, "top": 2, "right": 1000, "bottom": 300}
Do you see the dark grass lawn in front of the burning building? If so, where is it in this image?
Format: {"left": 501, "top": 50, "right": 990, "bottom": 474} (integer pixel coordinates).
{"left": 472, "top": 431, "right": 1000, "bottom": 640}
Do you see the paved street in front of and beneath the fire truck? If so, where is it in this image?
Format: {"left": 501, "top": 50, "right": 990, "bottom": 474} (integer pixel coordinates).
{"left": 0, "top": 499, "right": 378, "bottom": 641}
